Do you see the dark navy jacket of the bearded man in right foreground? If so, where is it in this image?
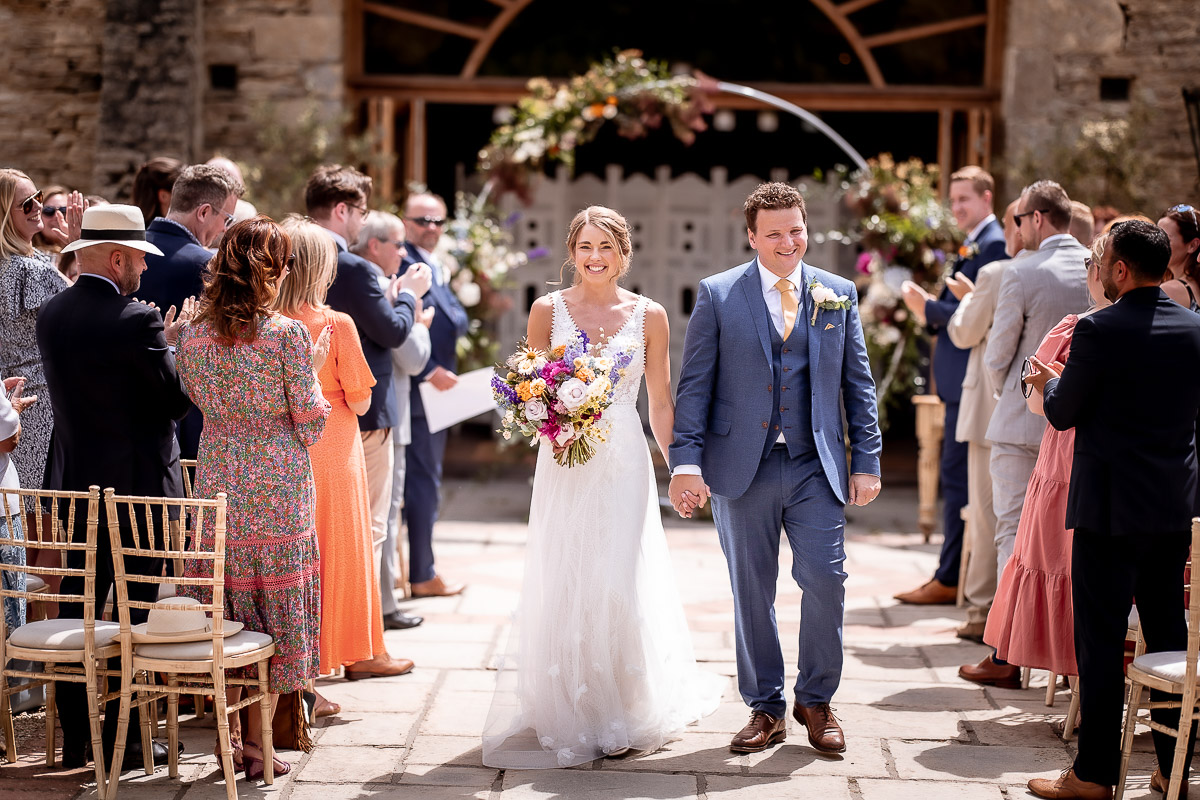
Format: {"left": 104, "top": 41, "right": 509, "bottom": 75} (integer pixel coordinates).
{"left": 1043, "top": 287, "right": 1200, "bottom": 536}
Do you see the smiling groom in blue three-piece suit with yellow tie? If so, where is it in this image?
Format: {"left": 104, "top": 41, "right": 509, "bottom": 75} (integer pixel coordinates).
{"left": 670, "top": 182, "right": 881, "bottom": 753}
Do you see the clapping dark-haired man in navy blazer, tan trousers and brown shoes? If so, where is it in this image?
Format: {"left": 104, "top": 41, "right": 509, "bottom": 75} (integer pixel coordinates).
{"left": 305, "top": 164, "right": 431, "bottom": 679}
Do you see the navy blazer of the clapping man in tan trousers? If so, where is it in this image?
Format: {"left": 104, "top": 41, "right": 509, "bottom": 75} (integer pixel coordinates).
{"left": 325, "top": 240, "right": 416, "bottom": 431}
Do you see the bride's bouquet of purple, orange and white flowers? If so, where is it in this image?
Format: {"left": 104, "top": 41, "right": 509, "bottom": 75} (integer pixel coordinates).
{"left": 492, "top": 331, "right": 632, "bottom": 467}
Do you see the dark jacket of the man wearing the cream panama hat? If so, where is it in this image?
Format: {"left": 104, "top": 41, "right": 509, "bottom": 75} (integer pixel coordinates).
{"left": 37, "top": 275, "right": 191, "bottom": 498}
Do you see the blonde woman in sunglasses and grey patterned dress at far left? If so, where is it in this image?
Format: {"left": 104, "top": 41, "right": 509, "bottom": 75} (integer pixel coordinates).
{"left": 0, "top": 169, "right": 68, "bottom": 510}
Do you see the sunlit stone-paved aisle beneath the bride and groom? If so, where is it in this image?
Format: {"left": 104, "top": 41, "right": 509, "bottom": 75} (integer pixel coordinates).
{"left": 0, "top": 482, "right": 1158, "bottom": 800}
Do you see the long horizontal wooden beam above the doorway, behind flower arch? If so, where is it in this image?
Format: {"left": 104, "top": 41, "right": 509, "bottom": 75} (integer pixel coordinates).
{"left": 348, "top": 76, "right": 1000, "bottom": 112}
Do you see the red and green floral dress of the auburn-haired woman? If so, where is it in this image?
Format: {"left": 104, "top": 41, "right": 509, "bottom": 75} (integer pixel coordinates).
{"left": 176, "top": 314, "right": 330, "bottom": 693}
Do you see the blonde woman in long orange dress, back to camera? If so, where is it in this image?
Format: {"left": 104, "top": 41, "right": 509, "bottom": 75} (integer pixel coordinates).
{"left": 276, "top": 217, "right": 388, "bottom": 716}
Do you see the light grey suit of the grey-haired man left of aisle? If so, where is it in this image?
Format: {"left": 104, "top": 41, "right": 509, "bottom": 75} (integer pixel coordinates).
{"left": 379, "top": 325, "right": 430, "bottom": 616}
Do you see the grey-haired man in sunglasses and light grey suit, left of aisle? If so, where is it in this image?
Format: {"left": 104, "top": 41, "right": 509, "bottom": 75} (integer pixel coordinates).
{"left": 350, "top": 211, "right": 434, "bottom": 630}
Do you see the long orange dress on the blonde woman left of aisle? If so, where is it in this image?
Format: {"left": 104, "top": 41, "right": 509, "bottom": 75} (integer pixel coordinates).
{"left": 283, "top": 306, "right": 386, "bottom": 674}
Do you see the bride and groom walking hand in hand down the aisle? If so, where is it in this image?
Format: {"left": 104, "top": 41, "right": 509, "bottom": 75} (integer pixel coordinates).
{"left": 484, "top": 182, "right": 881, "bottom": 769}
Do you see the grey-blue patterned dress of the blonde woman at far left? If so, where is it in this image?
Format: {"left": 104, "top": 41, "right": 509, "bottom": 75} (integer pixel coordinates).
{"left": 0, "top": 249, "right": 68, "bottom": 501}
